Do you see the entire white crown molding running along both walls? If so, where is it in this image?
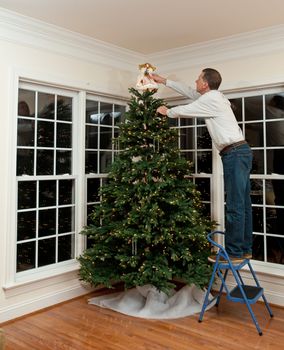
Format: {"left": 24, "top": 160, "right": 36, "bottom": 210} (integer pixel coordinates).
{"left": 0, "top": 8, "right": 284, "bottom": 74}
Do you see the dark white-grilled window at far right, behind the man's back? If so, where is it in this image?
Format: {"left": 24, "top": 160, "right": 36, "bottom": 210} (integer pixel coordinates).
{"left": 231, "top": 89, "right": 284, "bottom": 264}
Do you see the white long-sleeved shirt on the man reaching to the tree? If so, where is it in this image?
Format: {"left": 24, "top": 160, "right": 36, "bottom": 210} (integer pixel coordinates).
{"left": 166, "top": 80, "right": 244, "bottom": 151}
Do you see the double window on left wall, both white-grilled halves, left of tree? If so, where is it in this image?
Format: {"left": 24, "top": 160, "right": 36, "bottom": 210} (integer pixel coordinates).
{"left": 13, "top": 82, "right": 126, "bottom": 280}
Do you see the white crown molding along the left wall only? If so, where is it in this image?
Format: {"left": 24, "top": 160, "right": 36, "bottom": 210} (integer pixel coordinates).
{"left": 0, "top": 8, "right": 146, "bottom": 71}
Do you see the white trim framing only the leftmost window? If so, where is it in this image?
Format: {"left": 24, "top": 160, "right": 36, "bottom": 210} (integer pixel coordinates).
{"left": 3, "top": 69, "right": 86, "bottom": 291}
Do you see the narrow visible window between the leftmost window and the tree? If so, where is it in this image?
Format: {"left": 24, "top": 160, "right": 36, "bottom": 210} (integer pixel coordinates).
{"left": 85, "top": 95, "right": 126, "bottom": 238}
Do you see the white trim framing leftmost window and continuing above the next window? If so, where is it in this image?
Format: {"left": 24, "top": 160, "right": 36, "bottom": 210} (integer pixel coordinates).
{"left": 2, "top": 67, "right": 129, "bottom": 292}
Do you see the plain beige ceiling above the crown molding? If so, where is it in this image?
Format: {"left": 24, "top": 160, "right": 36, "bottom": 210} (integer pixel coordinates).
{"left": 0, "top": 0, "right": 284, "bottom": 55}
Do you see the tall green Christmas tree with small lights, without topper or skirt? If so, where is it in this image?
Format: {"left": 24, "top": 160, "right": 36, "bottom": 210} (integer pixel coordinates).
{"left": 78, "top": 88, "right": 212, "bottom": 293}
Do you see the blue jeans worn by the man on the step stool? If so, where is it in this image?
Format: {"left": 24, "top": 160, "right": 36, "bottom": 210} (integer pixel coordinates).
{"left": 221, "top": 144, "right": 253, "bottom": 257}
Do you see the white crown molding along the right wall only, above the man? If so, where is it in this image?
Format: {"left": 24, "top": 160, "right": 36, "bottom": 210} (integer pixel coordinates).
{"left": 147, "top": 25, "right": 284, "bottom": 73}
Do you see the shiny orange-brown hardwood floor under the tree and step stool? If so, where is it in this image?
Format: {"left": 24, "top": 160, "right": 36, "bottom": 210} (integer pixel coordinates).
{"left": 1, "top": 284, "right": 284, "bottom": 350}
